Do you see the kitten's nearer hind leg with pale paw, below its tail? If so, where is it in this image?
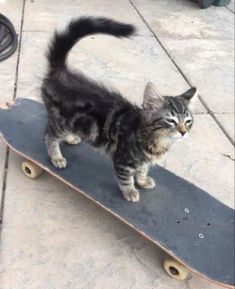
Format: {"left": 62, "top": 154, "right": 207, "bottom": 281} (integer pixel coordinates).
{"left": 45, "top": 134, "right": 67, "bottom": 169}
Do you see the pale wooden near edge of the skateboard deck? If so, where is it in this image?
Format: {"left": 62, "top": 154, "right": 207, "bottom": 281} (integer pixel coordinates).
{"left": 0, "top": 133, "right": 235, "bottom": 289}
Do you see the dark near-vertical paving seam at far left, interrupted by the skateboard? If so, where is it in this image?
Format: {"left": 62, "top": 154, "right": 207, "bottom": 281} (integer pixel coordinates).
{"left": 0, "top": 0, "right": 26, "bottom": 233}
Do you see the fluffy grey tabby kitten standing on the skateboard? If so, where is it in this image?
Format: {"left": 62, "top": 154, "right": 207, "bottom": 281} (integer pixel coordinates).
{"left": 42, "top": 17, "right": 196, "bottom": 202}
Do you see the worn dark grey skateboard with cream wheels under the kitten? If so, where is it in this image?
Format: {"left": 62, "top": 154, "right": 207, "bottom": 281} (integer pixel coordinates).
{"left": 0, "top": 98, "right": 235, "bottom": 288}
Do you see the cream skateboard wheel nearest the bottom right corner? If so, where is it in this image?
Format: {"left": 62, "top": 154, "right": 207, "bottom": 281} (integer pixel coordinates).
{"left": 163, "top": 258, "right": 189, "bottom": 280}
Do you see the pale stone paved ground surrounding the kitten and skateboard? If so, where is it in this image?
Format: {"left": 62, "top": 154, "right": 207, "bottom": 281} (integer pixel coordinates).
{"left": 0, "top": 0, "right": 234, "bottom": 289}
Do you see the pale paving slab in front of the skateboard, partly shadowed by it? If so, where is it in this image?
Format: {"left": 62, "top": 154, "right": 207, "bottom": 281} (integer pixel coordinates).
{"left": 0, "top": 154, "right": 224, "bottom": 289}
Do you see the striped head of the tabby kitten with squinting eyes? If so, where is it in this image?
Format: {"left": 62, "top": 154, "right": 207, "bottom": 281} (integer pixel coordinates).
{"left": 142, "top": 83, "right": 197, "bottom": 141}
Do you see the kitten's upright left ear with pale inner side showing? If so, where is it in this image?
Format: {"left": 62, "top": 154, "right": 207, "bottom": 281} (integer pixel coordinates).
{"left": 142, "top": 82, "right": 164, "bottom": 110}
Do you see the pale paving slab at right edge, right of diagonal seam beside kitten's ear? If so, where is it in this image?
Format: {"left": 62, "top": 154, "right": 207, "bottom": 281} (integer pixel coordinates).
{"left": 153, "top": 39, "right": 234, "bottom": 113}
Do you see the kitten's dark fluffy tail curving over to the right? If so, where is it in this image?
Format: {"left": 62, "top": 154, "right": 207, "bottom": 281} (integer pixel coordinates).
{"left": 47, "top": 17, "right": 135, "bottom": 70}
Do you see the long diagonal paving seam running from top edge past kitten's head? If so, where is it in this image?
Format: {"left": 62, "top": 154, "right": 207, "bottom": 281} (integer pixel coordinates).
{"left": 129, "top": 0, "right": 235, "bottom": 146}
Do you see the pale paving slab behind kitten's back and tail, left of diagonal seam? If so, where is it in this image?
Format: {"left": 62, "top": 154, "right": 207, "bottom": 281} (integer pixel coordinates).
{"left": 17, "top": 32, "right": 205, "bottom": 112}
